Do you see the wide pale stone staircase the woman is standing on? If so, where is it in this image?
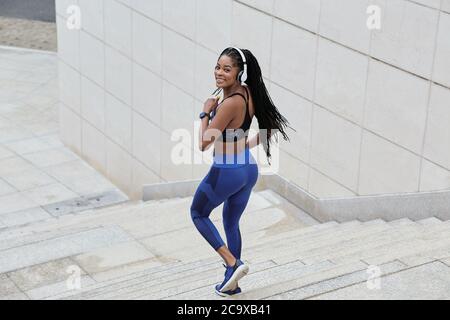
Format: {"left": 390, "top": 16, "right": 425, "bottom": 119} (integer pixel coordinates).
{"left": 0, "top": 190, "right": 450, "bottom": 300}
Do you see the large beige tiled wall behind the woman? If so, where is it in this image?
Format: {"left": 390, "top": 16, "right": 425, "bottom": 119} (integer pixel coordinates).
{"left": 56, "top": 0, "right": 450, "bottom": 198}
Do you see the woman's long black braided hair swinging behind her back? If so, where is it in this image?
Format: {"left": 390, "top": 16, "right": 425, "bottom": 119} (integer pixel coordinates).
{"left": 219, "top": 47, "right": 296, "bottom": 164}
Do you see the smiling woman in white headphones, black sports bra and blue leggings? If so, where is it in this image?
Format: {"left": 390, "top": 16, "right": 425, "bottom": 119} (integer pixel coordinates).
{"left": 190, "top": 47, "right": 289, "bottom": 296}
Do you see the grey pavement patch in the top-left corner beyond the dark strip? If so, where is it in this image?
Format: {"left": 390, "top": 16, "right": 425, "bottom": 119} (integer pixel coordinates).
{"left": 0, "top": 0, "right": 55, "bottom": 22}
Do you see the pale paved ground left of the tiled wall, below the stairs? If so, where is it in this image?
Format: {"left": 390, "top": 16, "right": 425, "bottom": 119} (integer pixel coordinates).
{"left": 0, "top": 47, "right": 123, "bottom": 229}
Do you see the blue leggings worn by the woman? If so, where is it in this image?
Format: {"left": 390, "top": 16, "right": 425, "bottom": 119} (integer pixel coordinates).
{"left": 191, "top": 151, "right": 258, "bottom": 259}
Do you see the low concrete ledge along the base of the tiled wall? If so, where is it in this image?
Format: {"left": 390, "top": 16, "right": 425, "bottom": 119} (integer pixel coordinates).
{"left": 143, "top": 174, "right": 450, "bottom": 222}
